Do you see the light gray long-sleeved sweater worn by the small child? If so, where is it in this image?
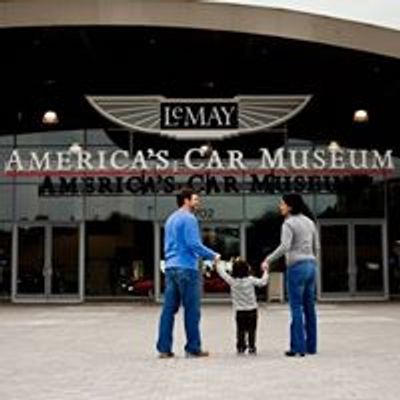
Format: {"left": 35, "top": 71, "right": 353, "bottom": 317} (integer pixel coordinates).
{"left": 217, "top": 264, "right": 268, "bottom": 311}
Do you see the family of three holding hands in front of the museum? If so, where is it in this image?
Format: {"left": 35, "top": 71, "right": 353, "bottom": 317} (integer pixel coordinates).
{"left": 157, "top": 189, "right": 319, "bottom": 358}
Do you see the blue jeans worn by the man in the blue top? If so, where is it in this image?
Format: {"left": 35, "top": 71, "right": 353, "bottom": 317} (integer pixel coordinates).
{"left": 157, "top": 268, "right": 201, "bottom": 353}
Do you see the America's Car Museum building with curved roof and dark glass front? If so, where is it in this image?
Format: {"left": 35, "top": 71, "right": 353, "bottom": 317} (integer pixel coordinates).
{"left": 0, "top": 0, "right": 400, "bottom": 302}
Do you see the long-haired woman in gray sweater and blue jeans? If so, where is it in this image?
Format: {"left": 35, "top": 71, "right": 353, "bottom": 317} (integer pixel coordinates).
{"left": 262, "top": 194, "right": 319, "bottom": 357}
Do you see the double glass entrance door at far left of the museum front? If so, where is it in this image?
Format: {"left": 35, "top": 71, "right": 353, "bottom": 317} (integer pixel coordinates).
{"left": 13, "top": 224, "right": 83, "bottom": 302}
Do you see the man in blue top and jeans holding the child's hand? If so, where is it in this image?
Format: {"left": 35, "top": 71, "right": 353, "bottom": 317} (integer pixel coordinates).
{"left": 157, "top": 189, "right": 220, "bottom": 358}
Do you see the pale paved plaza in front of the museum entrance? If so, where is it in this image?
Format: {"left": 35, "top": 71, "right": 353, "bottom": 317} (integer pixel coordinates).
{"left": 0, "top": 303, "right": 400, "bottom": 400}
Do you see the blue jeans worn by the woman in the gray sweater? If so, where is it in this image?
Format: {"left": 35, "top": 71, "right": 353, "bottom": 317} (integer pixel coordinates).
{"left": 287, "top": 260, "right": 317, "bottom": 354}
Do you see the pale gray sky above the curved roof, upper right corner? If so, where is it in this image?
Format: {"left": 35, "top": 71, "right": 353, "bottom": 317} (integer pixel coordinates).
{"left": 204, "top": 0, "right": 400, "bottom": 30}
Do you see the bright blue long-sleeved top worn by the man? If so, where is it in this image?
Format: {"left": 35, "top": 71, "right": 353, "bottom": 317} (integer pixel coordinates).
{"left": 164, "top": 209, "right": 217, "bottom": 269}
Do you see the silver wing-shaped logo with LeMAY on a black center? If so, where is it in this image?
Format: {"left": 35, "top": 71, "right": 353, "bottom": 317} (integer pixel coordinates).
{"left": 87, "top": 95, "right": 311, "bottom": 139}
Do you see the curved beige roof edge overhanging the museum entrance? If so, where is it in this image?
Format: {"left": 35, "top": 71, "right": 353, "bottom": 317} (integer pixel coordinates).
{"left": 0, "top": 0, "right": 400, "bottom": 58}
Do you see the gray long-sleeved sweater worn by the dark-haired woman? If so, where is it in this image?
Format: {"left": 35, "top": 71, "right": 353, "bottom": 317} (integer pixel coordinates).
{"left": 266, "top": 214, "right": 320, "bottom": 267}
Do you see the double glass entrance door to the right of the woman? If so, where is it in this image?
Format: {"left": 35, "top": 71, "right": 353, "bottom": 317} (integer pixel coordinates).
{"left": 319, "top": 220, "right": 388, "bottom": 299}
